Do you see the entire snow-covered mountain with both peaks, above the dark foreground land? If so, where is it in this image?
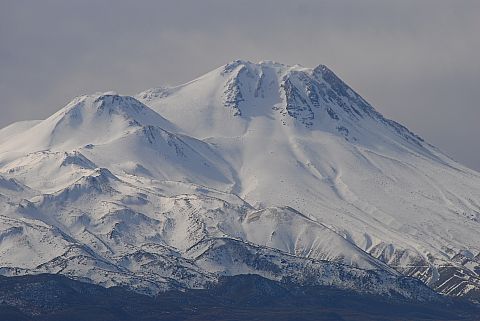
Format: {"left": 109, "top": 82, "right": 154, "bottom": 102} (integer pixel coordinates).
{"left": 0, "top": 61, "right": 480, "bottom": 299}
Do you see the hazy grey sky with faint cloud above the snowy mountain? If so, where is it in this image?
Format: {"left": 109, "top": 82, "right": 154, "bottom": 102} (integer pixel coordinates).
{"left": 0, "top": 0, "right": 480, "bottom": 170}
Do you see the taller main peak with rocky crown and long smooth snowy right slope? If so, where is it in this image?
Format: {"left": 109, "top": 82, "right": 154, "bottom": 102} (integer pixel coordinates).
{"left": 137, "top": 61, "right": 480, "bottom": 294}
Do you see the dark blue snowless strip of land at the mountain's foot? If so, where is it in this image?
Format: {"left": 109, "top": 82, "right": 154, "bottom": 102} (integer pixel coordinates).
{"left": 0, "top": 274, "right": 478, "bottom": 321}
